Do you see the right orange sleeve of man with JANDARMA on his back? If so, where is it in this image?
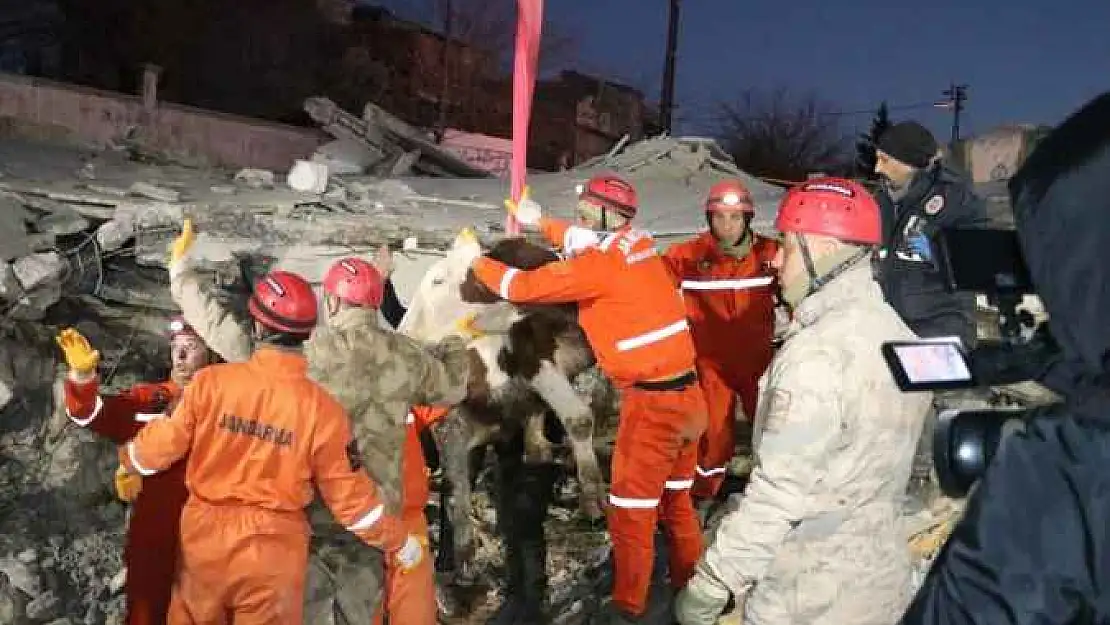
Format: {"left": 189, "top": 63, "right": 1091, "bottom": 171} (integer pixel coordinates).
{"left": 311, "top": 412, "right": 406, "bottom": 552}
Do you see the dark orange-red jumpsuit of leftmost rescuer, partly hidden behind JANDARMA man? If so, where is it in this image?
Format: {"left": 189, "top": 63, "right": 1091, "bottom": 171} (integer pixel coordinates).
{"left": 65, "top": 377, "right": 189, "bottom": 625}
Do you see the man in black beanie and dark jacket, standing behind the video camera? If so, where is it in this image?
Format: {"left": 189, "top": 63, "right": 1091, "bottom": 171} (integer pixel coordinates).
{"left": 875, "top": 121, "right": 989, "bottom": 500}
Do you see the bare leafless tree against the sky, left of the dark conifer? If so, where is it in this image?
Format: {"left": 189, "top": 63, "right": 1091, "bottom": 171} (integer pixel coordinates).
{"left": 715, "top": 89, "right": 851, "bottom": 181}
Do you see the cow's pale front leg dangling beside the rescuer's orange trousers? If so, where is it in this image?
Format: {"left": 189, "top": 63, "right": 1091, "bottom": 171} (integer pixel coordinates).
{"left": 528, "top": 360, "right": 605, "bottom": 518}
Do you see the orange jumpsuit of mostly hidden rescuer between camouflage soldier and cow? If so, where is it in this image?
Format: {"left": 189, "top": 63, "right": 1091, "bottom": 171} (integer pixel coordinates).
{"left": 374, "top": 406, "right": 447, "bottom": 625}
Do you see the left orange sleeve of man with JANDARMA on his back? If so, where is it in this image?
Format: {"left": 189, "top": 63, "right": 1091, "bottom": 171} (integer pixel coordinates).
{"left": 120, "top": 377, "right": 205, "bottom": 475}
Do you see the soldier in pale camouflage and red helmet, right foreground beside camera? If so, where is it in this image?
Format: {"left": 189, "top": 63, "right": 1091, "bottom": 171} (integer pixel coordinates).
{"left": 676, "top": 179, "right": 931, "bottom": 625}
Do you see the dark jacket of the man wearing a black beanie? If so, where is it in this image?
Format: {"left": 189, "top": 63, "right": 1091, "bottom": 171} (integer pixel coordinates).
{"left": 877, "top": 162, "right": 988, "bottom": 346}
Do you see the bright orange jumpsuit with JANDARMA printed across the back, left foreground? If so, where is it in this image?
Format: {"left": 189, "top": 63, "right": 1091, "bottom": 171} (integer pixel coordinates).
{"left": 120, "top": 346, "right": 405, "bottom": 625}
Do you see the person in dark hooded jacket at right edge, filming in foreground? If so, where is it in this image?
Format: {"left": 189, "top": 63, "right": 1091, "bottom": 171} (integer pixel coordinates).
{"left": 901, "top": 93, "right": 1110, "bottom": 625}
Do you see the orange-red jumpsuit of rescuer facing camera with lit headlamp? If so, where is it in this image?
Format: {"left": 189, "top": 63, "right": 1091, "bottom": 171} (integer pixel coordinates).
{"left": 663, "top": 232, "right": 778, "bottom": 498}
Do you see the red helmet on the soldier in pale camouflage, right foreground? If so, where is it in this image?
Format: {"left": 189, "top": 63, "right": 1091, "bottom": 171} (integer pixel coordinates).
{"left": 775, "top": 178, "right": 882, "bottom": 245}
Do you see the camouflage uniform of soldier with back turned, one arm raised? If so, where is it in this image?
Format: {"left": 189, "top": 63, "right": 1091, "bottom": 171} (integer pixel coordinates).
{"left": 170, "top": 220, "right": 470, "bottom": 625}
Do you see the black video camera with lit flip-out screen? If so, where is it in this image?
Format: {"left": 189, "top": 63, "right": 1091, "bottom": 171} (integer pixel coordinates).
{"left": 882, "top": 229, "right": 1059, "bottom": 496}
